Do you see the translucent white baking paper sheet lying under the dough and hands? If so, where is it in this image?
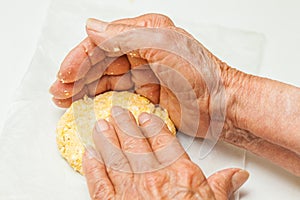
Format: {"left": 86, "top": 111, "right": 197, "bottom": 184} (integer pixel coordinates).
{"left": 0, "top": 0, "right": 264, "bottom": 200}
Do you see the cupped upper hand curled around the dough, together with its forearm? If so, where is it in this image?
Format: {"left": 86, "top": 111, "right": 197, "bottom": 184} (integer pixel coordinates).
{"left": 50, "top": 14, "right": 300, "bottom": 176}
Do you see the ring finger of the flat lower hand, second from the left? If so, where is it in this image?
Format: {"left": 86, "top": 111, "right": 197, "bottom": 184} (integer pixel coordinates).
{"left": 93, "top": 119, "right": 133, "bottom": 188}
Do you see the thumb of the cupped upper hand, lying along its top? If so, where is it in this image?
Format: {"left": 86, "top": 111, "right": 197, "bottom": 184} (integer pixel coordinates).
{"left": 86, "top": 19, "right": 187, "bottom": 60}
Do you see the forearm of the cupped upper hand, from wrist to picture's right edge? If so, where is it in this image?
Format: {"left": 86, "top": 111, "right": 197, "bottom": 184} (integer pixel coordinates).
{"left": 222, "top": 66, "right": 300, "bottom": 175}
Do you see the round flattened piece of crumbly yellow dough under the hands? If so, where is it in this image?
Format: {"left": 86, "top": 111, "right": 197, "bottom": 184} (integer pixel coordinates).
{"left": 56, "top": 91, "right": 176, "bottom": 174}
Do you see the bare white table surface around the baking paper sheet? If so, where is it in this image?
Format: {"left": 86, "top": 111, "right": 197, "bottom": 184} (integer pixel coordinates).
{"left": 0, "top": 0, "right": 300, "bottom": 199}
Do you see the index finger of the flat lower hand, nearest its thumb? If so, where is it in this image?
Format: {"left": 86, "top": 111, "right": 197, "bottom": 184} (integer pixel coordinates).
{"left": 139, "top": 113, "right": 189, "bottom": 165}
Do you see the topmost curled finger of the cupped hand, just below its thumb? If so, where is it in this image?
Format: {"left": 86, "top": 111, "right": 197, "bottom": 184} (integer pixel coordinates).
{"left": 57, "top": 38, "right": 105, "bottom": 83}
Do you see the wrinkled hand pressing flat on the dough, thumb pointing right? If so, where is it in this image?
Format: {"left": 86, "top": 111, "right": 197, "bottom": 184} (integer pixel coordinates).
{"left": 83, "top": 107, "right": 248, "bottom": 200}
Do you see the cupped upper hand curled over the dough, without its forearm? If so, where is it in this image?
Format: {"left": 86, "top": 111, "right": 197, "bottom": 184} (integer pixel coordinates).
{"left": 50, "top": 14, "right": 224, "bottom": 137}
